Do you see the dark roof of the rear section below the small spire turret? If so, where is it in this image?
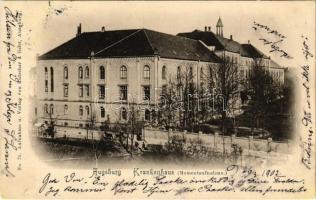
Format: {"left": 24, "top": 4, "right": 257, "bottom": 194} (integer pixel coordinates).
{"left": 178, "top": 30, "right": 241, "bottom": 53}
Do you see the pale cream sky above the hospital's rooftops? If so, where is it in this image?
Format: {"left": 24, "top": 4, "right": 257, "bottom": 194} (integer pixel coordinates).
{"left": 6, "top": 1, "right": 315, "bottom": 67}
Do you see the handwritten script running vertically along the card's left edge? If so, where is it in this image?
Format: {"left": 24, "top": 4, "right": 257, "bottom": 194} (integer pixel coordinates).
{"left": 0, "top": 7, "right": 23, "bottom": 177}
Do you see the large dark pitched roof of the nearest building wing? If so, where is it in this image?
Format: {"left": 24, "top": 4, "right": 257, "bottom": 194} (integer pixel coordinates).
{"left": 39, "top": 29, "right": 220, "bottom": 62}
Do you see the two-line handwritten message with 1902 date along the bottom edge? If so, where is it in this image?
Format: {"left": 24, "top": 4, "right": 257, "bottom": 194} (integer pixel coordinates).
{"left": 38, "top": 165, "right": 307, "bottom": 198}
